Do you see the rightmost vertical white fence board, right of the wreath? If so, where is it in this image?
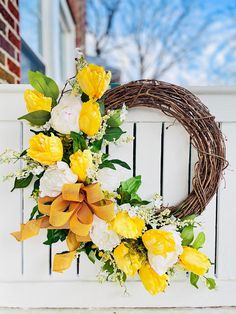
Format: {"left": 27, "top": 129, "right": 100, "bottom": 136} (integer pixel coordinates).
{"left": 217, "top": 123, "right": 236, "bottom": 279}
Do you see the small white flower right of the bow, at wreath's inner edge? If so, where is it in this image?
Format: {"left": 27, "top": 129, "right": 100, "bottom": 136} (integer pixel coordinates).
{"left": 97, "top": 166, "right": 124, "bottom": 191}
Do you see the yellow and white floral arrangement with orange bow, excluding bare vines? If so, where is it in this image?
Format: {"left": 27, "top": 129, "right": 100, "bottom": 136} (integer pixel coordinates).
{"left": 0, "top": 56, "right": 215, "bottom": 295}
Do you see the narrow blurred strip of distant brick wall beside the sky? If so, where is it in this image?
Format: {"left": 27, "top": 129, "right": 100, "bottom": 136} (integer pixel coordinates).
{"left": 67, "top": 0, "right": 86, "bottom": 51}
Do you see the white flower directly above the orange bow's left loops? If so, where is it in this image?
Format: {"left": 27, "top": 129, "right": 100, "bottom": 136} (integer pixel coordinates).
{"left": 39, "top": 161, "right": 78, "bottom": 197}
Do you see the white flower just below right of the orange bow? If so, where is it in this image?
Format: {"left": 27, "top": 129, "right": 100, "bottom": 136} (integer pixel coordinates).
{"left": 90, "top": 215, "right": 120, "bottom": 251}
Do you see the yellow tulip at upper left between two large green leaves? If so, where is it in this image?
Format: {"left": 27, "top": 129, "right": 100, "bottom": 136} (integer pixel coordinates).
{"left": 24, "top": 89, "right": 52, "bottom": 112}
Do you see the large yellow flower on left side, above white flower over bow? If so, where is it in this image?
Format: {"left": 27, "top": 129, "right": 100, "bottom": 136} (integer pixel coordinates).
{"left": 27, "top": 133, "right": 63, "bottom": 165}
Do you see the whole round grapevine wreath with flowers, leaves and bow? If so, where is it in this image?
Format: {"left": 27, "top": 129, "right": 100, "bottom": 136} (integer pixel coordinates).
{"left": 0, "top": 55, "right": 226, "bottom": 295}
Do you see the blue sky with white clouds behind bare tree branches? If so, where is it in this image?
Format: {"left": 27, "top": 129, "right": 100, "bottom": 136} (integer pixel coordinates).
{"left": 87, "top": 0, "right": 236, "bottom": 85}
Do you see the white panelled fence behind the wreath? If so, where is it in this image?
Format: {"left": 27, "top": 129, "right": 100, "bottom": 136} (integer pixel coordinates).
{"left": 0, "top": 85, "right": 236, "bottom": 307}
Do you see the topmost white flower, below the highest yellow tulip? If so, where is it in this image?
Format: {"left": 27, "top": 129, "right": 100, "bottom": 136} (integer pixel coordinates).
{"left": 50, "top": 95, "right": 82, "bottom": 134}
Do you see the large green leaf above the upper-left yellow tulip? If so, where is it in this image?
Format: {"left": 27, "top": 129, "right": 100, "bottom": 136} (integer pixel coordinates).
{"left": 29, "top": 71, "right": 59, "bottom": 105}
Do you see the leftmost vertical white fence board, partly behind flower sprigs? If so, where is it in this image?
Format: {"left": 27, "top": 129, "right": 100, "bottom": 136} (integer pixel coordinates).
{"left": 0, "top": 121, "right": 22, "bottom": 280}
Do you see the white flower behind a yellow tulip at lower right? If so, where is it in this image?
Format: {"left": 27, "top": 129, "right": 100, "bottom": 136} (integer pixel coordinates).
{"left": 148, "top": 225, "right": 183, "bottom": 275}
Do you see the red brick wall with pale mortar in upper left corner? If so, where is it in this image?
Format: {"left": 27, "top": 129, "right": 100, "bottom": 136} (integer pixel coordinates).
{"left": 0, "top": 0, "right": 21, "bottom": 84}
